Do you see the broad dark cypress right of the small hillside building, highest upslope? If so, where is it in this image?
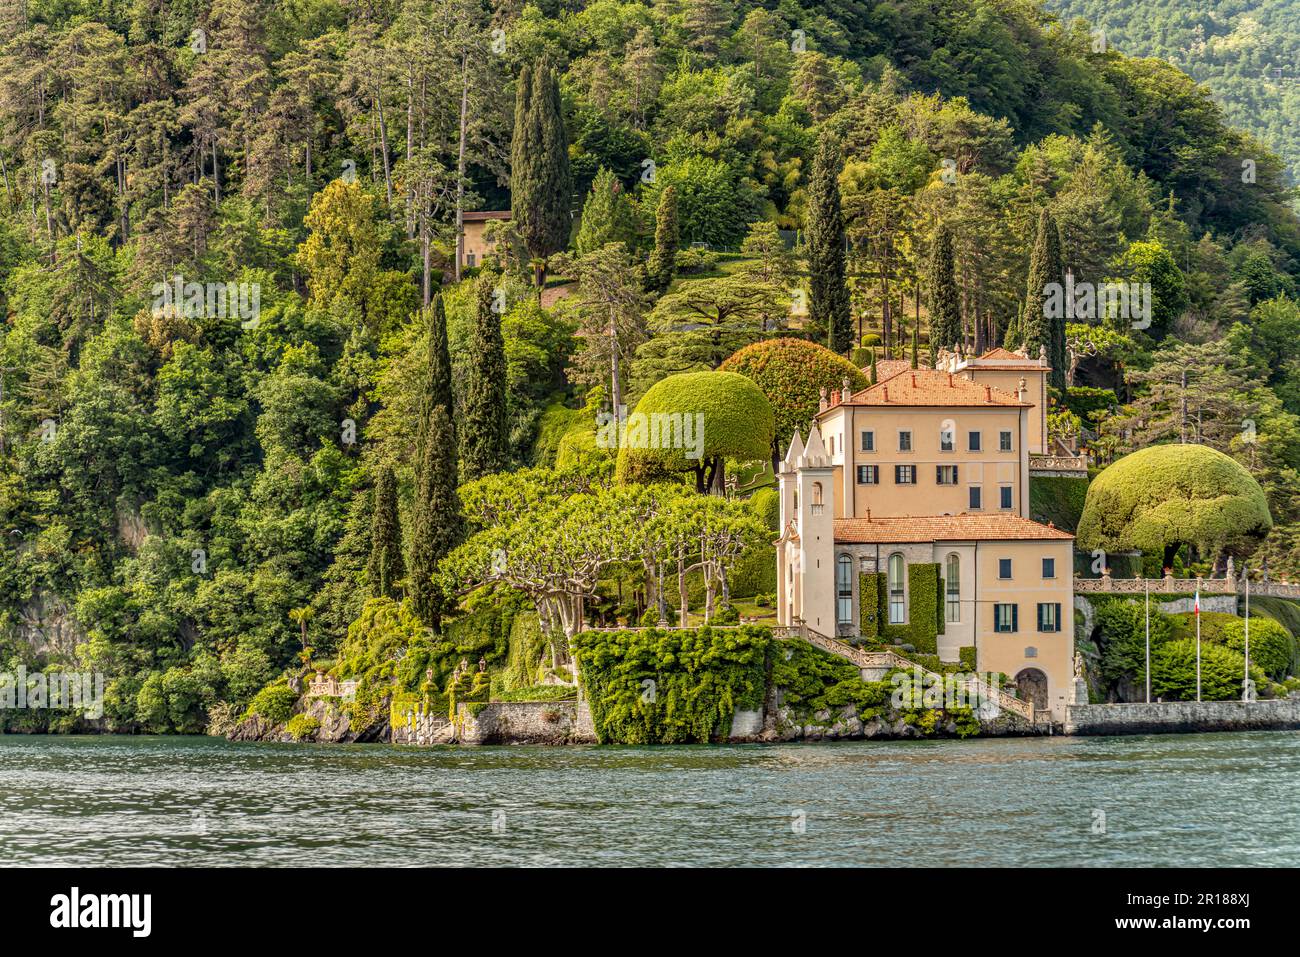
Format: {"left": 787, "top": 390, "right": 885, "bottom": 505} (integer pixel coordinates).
{"left": 510, "top": 62, "right": 573, "bottom": 286}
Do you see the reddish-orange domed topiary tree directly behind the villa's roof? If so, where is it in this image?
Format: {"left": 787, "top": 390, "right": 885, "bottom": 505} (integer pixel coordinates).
{"left": 718, "top": 338, "right": 868, "bottom": 471}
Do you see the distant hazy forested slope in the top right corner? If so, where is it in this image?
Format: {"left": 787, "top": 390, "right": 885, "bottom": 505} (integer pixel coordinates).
{"left": 1047, "top": 0, "right": 1300, "bottom": 188}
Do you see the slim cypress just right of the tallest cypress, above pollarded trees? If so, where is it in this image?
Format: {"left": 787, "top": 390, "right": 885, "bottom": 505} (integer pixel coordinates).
{"left": 460, "top": 270, "right": 508, "bottom": 482}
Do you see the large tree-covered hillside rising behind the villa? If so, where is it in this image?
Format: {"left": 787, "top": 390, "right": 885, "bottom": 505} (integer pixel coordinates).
{"left": 0, "top": 0, "right": 1300, "bottom": 731}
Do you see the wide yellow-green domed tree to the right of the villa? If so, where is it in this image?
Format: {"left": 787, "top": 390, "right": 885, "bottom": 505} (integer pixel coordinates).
{"left": 1078, "top": 445, "right": 1273, "bottom": 568}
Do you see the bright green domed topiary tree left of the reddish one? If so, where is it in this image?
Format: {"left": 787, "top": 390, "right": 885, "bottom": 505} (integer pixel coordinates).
{"left": 616, "top": 372, "right": 774, "bottom": 494}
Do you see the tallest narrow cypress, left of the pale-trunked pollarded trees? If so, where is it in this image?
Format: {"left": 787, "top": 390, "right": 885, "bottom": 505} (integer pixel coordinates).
{"left": 411, "top": 295, "right": 462, "bottom": 631}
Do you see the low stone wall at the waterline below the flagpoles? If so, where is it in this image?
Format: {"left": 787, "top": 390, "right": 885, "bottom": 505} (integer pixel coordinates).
{"left": 1065, "top": 698, "right": 1300, "bottom": 735}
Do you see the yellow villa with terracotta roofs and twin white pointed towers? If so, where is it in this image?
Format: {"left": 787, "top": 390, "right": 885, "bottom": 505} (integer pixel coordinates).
{"left": 776, "top": 350, "right": 1075, "bottom": 720}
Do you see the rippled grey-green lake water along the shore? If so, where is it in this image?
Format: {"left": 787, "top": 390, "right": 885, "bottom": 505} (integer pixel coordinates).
{"left": 0, "top": 732, "right": 1300, "bottom": 866}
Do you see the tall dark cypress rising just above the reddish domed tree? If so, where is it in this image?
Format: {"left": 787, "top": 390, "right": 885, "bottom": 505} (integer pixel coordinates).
{"left": 807, "top": 133, "right": 853, "bottom": 355}
